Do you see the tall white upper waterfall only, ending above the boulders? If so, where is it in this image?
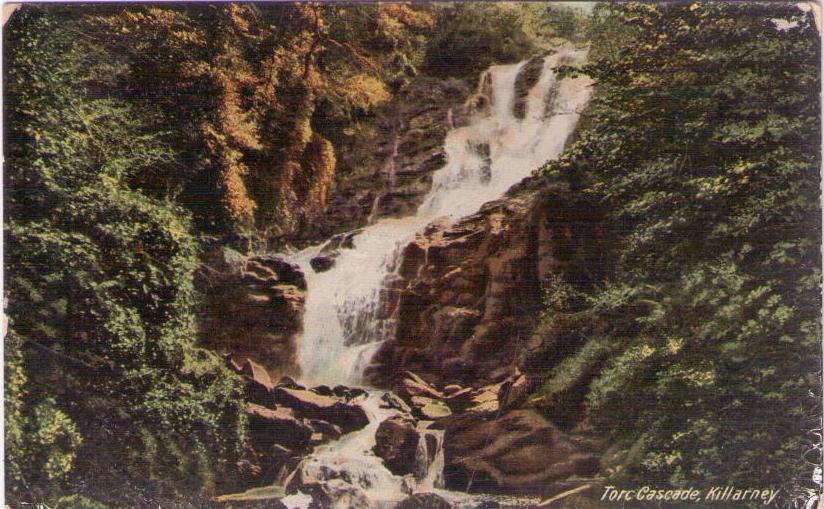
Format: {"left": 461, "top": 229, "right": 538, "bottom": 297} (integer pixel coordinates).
{"left": 293, "top": 49, "right": 589, "bottom": 383}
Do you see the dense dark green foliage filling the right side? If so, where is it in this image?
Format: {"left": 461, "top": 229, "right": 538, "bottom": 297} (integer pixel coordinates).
{"left": 538, "top": 3, "right": 821, "bottom": 495}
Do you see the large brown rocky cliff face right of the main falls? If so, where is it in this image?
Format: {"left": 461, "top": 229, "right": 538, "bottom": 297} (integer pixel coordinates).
{"left": 367, "top": 178, "right": 605, "bottom": 386}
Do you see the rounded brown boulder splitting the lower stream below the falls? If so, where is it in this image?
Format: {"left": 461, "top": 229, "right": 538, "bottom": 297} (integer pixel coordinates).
{"left": 373, "top": 416, "right": 421, "bottom": 475}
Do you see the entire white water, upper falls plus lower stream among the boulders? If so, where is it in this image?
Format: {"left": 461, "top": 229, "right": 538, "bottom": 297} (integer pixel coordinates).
{"left": 284, "top": 49, "right": 590, "bottom": 507}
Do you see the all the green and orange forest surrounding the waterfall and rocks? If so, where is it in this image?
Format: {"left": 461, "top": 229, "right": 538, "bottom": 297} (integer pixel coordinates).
{"left": 4, "top": 2, "right": 821, "bottom": 509}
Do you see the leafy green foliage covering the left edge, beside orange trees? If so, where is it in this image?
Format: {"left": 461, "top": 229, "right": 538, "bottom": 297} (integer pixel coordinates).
{"left": 5, "top": 7, "right": 244, "bottom": 505}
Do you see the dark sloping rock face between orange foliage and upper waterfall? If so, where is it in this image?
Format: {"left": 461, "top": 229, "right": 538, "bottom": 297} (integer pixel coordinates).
{"left": 294, "top": 76, "right": 471, "bottom": 241}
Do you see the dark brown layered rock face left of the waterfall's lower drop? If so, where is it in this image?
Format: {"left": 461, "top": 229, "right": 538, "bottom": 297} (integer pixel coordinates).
{"left": 195, "top": 247, "right": 306, "bottom": 379}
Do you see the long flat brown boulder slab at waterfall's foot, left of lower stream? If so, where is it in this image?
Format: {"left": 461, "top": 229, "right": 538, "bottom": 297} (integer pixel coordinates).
{"left": 272, "top": 386, "right": 369, "bottom": 433}
